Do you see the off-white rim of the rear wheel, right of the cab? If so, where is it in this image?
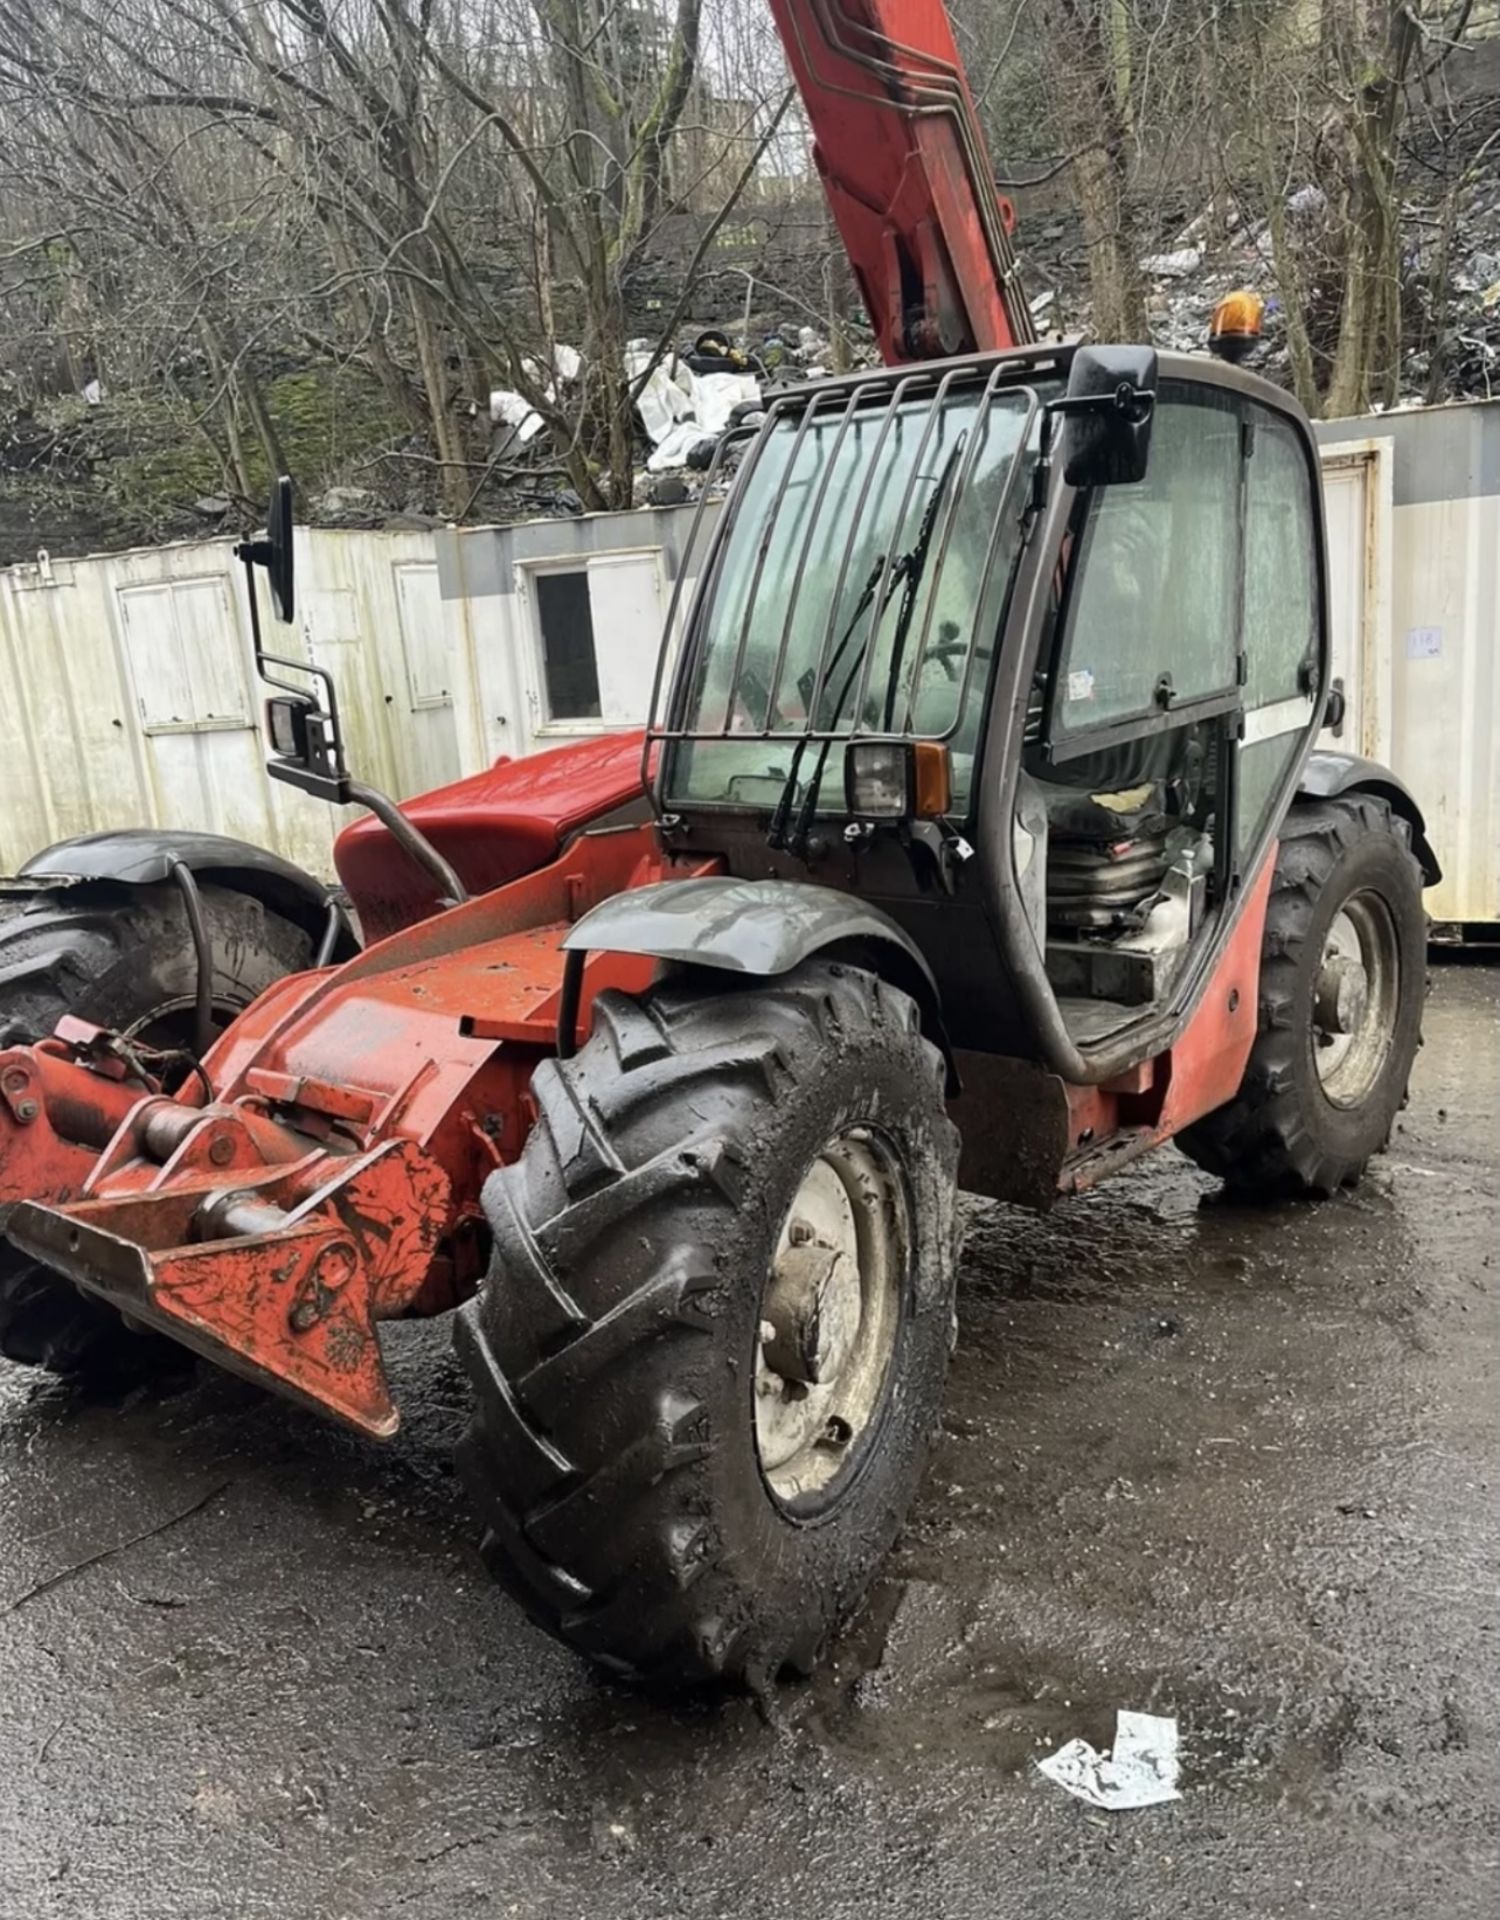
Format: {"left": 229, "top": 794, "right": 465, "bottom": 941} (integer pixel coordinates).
{"left": 1312, "top": 893, "right": 1400, "bottom": 1108}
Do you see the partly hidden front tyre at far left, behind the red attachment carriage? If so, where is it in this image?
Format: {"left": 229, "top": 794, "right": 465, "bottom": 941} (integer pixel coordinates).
{"left": 0, "top": 885, "right": 313, "bottom": 1386}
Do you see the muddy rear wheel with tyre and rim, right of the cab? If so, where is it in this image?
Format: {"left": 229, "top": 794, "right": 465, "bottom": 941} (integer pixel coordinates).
{"left": 1179, "top": 793, "right": 1427, "bottom": 1200}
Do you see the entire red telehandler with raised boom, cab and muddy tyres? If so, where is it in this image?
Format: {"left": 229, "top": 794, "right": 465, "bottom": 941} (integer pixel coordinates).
{"left": 0, "top": 0, "right": 1437, "bottom": 1684}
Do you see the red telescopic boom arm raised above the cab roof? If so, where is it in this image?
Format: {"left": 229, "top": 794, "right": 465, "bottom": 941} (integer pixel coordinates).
{"left": 770, "top": 0, "right": 1037, "bottom": 365}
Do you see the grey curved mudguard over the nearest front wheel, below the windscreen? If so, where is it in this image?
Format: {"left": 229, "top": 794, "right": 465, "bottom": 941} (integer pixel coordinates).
{"left": 563, "top": 876, "right": 956, "bottom": 1089}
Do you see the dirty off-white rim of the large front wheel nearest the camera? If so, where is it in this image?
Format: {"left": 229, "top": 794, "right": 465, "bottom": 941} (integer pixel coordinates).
{"left": 755, "top": 1127, "right": 910, "bottom": 1505}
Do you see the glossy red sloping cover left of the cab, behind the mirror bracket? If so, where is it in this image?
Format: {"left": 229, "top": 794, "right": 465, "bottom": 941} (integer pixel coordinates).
{"left": 334, "top": 733, "right": 645, "bottom": 943}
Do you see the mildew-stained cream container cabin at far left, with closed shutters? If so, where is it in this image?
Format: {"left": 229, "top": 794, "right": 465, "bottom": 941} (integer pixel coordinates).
{"left": 0, "top": 530, "right": 461, "bottom": 876}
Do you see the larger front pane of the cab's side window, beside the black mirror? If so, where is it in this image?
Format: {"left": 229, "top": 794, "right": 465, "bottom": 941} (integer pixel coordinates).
{"left": 1052, "top": 382, "right": 1243, "bottom": 739}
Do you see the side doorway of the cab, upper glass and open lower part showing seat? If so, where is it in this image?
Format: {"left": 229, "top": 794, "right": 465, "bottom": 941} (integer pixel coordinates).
{"left": 1016, "top": 369, "right": 1323, "bottom": 1043}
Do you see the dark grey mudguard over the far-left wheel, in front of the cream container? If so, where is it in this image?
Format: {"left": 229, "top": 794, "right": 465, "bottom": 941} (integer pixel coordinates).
{"left": 0, "top": 828, "right": 359, "bottom": 960}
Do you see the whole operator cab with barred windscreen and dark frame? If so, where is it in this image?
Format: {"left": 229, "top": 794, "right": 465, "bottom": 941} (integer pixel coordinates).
{"left": 653, "top": 337, "right": 1325, "bottom": 1056}
